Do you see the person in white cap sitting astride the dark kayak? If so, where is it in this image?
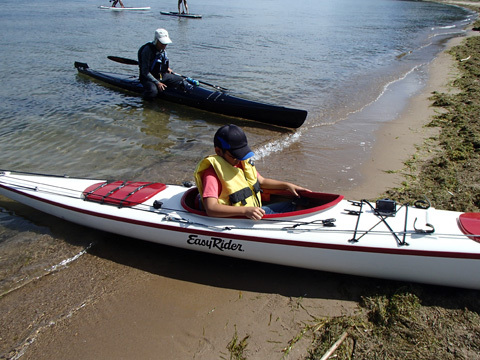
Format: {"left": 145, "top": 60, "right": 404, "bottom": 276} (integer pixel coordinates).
{"left": 138, "top": 29, "right": 185, "bottom": 100}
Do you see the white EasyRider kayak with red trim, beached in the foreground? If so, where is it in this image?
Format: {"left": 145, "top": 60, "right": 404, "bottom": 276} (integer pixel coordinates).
{"left": 0, "top": 171, "right": 480, "bottom": 289}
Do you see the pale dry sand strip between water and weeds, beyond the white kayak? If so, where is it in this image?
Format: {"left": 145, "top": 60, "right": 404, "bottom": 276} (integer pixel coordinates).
{"left": 347, "top": 34, "right": 464, "bottom": 199}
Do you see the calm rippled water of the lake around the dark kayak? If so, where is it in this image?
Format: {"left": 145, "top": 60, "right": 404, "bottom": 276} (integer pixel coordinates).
{"left": 0, "top": 0, "right": 471, "bottom": 292}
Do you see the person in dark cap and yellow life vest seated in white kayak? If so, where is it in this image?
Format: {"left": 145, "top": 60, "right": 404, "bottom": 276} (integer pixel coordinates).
{"left": 194, "top": 125, "right": 310, "bottom": 220}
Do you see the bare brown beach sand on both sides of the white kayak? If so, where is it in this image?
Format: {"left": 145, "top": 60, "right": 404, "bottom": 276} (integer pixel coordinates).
{"left": 0, "top": 5, "right": 474, "bottom": 360}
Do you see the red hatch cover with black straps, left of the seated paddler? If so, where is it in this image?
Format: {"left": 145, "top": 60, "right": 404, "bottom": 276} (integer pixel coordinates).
{"left": 83, "top": 181, "right": 167, "bottom": 207}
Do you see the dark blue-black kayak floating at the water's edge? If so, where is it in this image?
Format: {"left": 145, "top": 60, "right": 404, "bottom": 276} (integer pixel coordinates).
{"left": 75, "top": 62, "right": 307, "bottom": 129}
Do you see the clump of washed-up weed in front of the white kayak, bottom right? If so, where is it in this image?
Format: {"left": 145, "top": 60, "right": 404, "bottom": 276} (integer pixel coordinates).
{"left": 307, "top": 285, "right": 480, "bottom": 360}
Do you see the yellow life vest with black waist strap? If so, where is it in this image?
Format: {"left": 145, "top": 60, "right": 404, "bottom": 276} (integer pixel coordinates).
{"left": 194, "top": 155, "right": 262, "bottom": 206}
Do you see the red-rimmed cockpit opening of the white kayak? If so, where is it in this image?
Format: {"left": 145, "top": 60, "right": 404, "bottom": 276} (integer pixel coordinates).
{"left": 182, "top": 187, "right": 344, "bottom": 219}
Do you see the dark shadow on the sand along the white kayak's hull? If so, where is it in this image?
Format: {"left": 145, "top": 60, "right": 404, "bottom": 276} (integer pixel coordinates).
{"left": 89, "top": 228, "right": 480, "bottom": 312}
